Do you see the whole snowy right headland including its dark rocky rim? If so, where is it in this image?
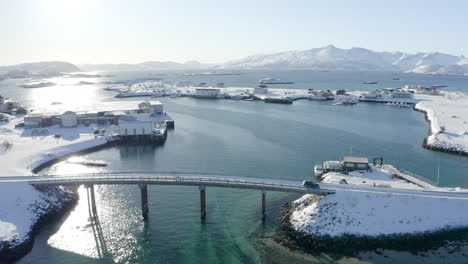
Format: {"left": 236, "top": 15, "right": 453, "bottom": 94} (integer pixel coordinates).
{"left": 281, "top": 165, "right": 468, "bottom": 252}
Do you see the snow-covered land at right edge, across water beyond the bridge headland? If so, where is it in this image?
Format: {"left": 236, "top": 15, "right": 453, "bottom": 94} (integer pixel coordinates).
{"left": 415, "top": 91, "right": 468, "bottom": 153}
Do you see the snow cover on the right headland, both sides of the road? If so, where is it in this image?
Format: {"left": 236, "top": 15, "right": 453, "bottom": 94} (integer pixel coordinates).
{"left": 290, "top": 166, "right": 468, "bottom": 237}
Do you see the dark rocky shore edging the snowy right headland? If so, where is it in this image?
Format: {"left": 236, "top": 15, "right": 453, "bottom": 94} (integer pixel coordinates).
{"left": 275, "top": 196, "right": 468, "bottom": 258}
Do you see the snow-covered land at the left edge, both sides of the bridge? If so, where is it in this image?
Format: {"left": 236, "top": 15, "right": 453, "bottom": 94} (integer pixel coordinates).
{"left": 0, "top": 118, "right": 113, "bottom": 249}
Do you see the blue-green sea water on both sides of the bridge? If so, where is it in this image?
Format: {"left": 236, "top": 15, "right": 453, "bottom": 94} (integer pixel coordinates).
{"left": 0, "top": 72, "right": 468, "bottom": 263}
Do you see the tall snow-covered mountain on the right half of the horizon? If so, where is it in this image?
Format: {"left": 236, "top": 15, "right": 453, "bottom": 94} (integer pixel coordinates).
{"left": 220, "top": 45, "right": 468, "bottom": 74}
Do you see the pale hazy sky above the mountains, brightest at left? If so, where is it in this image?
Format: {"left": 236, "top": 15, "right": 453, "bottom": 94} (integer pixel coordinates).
{"left": 0, "top": 0, "right": 468, "bottom": 65}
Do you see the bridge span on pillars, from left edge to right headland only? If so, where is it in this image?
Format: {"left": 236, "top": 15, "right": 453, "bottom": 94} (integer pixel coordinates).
{"left": 0, "top": 172, "right": 335, "bottom": 219}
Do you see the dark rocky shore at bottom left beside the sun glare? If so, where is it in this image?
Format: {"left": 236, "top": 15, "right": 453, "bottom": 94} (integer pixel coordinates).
{"left": 0, "top": 186, "right": 78, "bottom": 263}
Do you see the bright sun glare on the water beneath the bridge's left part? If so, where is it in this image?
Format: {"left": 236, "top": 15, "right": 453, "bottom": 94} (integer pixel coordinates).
{"left": 47, "top": 186, "right": 144, "bottom": 263}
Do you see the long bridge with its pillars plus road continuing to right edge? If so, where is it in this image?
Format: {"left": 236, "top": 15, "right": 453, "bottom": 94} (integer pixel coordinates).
{"left": 0, "top": 172, "right": 468, "bottom": 219}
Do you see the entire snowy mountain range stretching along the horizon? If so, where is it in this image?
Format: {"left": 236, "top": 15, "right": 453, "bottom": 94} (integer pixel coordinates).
{"left": 0, "top": 45, "right": 468, "bottom": 78}
